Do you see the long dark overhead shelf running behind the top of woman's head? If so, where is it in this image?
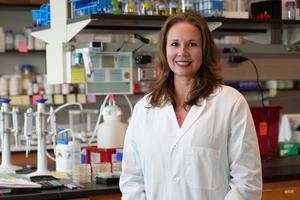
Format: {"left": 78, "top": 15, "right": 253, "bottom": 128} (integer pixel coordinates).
{"left": 34, "top": 14, "right": 300, "bottom": 34}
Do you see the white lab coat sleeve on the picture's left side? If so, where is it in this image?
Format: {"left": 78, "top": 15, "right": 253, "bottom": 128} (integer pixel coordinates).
{"left": 119, "top": 105, "right": 146, "bottom": 200}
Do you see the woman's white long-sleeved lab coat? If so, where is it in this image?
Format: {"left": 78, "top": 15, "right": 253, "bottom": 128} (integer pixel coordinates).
{"left": 120, "top": 86, "right": 262, "bottom": 200}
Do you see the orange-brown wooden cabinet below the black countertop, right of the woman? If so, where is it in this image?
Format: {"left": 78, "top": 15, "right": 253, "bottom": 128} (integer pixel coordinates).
{"left": 262, "top": 180, "right": 300, "bottom": 200}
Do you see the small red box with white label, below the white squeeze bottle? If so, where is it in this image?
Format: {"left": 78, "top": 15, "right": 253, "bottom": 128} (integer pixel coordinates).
{"left": 83, "top": 146, "right": 116, "bottom": 164}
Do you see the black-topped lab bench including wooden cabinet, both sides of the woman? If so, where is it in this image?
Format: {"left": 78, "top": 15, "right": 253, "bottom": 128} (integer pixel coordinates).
{"left": 0, "top": 155, "right": 300, "bottom": 200}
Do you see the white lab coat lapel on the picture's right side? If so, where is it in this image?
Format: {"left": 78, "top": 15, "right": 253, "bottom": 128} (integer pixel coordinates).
{"left": 172, "top": 99, "right": 206, "bottom": 150}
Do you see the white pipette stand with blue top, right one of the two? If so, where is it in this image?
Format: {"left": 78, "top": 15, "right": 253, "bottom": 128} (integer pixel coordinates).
{"left": 25, "top": 99, "right": 53, "bottom": 177}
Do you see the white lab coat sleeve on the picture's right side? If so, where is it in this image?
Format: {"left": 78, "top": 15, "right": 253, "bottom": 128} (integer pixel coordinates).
{"left": 225, "top": 97, "right": 262, "bottom": 200}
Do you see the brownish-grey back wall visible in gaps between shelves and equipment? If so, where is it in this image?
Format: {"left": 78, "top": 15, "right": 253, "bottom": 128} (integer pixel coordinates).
{"left": 0, "top": 6, "right": 300, "bottom": 124}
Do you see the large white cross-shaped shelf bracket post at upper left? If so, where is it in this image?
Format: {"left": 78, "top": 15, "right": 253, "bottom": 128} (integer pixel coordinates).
{"left": 32, "top": 0, "right": 91, "bottom": 84}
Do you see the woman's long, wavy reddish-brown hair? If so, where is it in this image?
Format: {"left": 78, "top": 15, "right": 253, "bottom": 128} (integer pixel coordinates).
{"left": 148, "top": 11, "right": 223, "bottom": 107}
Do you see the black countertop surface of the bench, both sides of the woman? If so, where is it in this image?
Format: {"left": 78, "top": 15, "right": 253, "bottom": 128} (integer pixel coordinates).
{"left": 0, "top": 155, "right": 300, "bottom": 200}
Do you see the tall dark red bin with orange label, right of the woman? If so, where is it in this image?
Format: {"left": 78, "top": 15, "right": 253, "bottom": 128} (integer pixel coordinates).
{"left": 250, "top": 106, "right": 282, "bottom": 157}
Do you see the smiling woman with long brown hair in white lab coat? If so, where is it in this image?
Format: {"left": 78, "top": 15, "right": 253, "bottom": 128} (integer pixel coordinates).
{"left": 120, "top": 12, "right": 262, "bottom": 200}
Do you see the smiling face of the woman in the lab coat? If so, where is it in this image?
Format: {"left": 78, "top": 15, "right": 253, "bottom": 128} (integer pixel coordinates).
{"left": 166, "top": 22, "right": 202, "bottom": 80}
